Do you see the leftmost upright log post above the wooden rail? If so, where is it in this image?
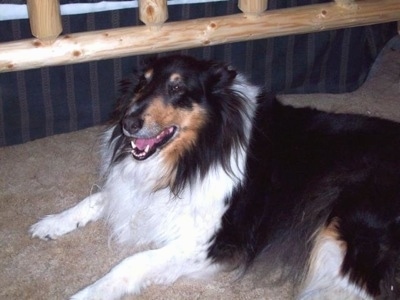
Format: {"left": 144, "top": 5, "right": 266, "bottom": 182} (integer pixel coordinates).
{"left": 27, "top": 0, "right": 62, "bottom": 44}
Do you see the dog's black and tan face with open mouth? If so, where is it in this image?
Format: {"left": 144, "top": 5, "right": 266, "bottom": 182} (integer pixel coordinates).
{"left": 121, "top": 56, "right": 236, "bottom": 160}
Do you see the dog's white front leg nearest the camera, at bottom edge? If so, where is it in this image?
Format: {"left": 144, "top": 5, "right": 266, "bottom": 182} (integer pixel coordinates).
{"left": 71, "top": 242, "right": 207, "bottom": 300}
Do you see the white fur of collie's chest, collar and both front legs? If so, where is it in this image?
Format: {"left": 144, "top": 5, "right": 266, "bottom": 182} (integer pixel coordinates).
{"left": 30, "top": 76, "right": 259, "bottom": 299}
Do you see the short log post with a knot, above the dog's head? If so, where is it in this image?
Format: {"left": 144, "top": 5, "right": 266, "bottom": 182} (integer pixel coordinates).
{"left": 139, "top": 0, "right": 168, "bottom": 31}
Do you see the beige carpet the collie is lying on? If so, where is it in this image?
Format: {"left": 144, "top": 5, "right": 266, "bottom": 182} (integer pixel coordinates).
{"left": 0, "top": 37, "right": 400, "bottom": 300}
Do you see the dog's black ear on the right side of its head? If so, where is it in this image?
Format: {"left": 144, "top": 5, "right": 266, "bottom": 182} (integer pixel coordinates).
{"left": 207, "top": 64, "right": 237, "bottom": 91}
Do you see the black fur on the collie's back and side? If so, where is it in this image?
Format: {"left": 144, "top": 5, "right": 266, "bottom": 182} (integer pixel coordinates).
{"left": 209, "top": 96, "right": 400, "bottom": 297}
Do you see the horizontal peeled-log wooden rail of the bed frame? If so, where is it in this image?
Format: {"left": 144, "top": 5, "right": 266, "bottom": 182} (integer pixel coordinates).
{"left": 0, "top": 0, "right": 400, "bottom": 72}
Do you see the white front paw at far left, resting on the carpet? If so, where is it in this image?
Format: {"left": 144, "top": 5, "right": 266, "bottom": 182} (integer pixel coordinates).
{"left": 29, "top": 214, "right": 79, "bottom": 241}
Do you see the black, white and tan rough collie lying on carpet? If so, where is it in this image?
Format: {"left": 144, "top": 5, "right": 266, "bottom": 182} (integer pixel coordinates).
{"left": 31, "top": 56, "right": 400, "bottom": 299}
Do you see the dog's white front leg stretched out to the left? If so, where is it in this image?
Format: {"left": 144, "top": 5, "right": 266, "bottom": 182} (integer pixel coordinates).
{"left": 29, "top": 192, "right": 104, "bottom": 240}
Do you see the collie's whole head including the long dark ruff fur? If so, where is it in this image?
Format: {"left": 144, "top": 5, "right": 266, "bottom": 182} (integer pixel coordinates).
{"left": 109, "top": 56, "right": 260, "bottom": 195}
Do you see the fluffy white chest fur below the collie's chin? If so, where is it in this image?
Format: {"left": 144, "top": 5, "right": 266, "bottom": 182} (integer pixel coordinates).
{"left": 102, "top": 152, "right": 237, "bottom": 247}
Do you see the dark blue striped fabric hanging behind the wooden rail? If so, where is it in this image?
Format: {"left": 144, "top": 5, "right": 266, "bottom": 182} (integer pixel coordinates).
{"left": 0, "top": 0, "right": 396, "bottom": 146}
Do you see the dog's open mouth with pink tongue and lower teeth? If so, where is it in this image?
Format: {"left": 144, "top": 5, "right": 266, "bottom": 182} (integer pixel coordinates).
{"left": 131, "top": 126, "right": 176, "bottom": 160}
